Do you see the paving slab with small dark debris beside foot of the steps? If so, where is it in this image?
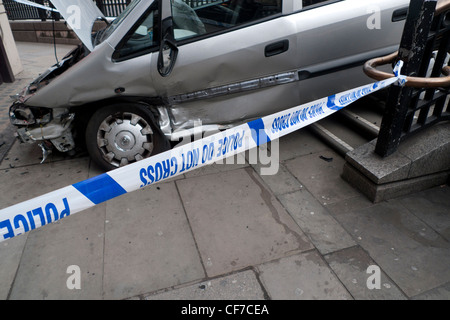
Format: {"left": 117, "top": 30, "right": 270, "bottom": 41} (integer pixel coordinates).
{"left": 286, "top": 150, "right": 360, "bottom": 205}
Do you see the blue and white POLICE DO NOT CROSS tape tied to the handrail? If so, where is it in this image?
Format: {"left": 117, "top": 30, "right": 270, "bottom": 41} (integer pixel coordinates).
{"left": 0, "top": 61, "right": 405, "bottom": 242}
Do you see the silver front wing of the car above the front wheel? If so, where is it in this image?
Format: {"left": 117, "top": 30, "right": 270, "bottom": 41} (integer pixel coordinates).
{"left": 26, "top": 42, "right": 157, "bottom": 108}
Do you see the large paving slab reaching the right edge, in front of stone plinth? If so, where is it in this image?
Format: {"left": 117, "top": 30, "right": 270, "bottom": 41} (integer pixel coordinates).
{"left": 335, "top": 201, "right": 450, "bottom": 297}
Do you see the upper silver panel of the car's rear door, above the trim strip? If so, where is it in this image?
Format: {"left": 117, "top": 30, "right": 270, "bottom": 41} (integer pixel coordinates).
{"left": 296, "top": 0, "right": 409, "bottom": 67}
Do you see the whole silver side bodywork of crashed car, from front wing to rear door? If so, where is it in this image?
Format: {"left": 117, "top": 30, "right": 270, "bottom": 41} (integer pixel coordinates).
{"left": 22, "top": 0, "right": 409, "bottom": 129}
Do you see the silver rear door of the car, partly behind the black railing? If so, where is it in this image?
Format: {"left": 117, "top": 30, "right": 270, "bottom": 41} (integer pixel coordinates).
{"left": 294, "top": 0, "right": 409, "bottom": 102}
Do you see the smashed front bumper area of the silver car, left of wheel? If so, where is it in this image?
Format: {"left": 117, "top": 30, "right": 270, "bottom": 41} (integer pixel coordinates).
{"left": 9, "top": 102, "right": 75, "bottom": 152}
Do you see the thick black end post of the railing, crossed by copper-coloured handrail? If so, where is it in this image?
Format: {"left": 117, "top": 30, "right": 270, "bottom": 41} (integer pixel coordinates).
{"left": 375, "top": 0, "right": 437, "bottom": 157}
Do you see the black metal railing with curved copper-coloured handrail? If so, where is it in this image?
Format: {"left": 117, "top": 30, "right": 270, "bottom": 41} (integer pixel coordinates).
{"left": 364, "top": 0, "right": 450, "bottom": 157}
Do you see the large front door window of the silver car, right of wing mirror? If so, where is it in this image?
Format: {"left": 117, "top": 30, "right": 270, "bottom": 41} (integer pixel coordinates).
{"left": 171, "top": 0, "right": 282, "bottom": 40}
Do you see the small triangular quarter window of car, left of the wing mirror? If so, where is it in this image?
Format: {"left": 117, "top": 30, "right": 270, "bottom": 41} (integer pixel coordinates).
{"left": 114, "top": 9, "right": 158, "bottom": 60}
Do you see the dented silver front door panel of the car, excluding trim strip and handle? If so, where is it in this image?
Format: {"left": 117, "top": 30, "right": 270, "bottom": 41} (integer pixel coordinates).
{"left": 151, "top": 16, "right": 299, "bottom": 130}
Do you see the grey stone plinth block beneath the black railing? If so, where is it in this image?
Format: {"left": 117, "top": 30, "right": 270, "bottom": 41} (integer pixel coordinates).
{"left": 341, "top": 122, "right": 450, "bottom": 202}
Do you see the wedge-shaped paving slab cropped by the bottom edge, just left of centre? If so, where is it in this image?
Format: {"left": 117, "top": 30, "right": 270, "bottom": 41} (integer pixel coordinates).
{"left": 144, "top": 270, "right": 265, "bottom": 300}
